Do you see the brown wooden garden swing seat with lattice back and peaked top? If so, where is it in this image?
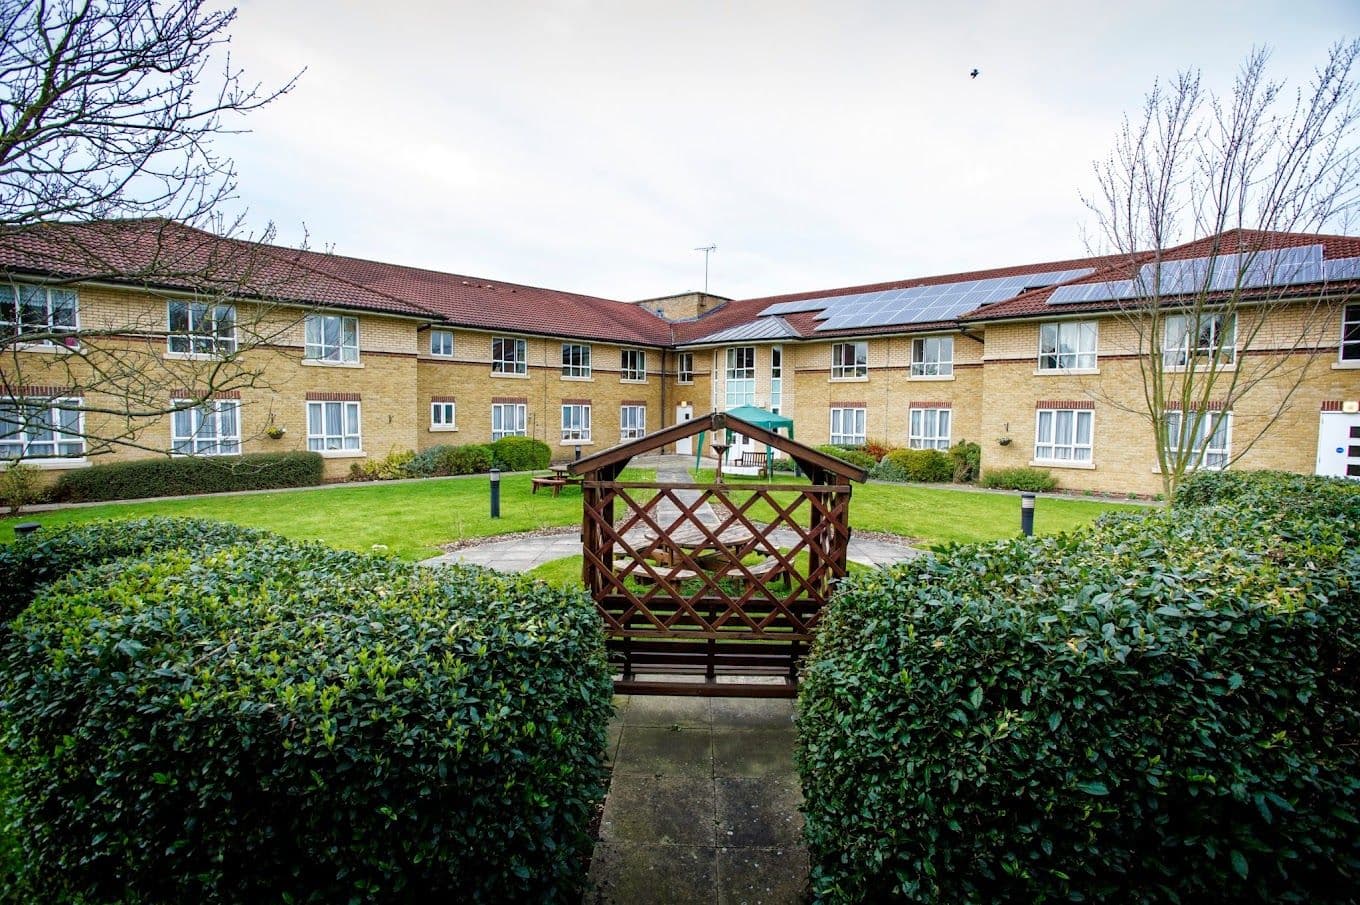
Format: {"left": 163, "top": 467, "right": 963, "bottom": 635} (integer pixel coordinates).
{"left": 570, "top": 412, "right": 866, "bottom": 697}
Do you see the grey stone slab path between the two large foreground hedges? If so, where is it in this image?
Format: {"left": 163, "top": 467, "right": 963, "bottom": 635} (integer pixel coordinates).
{"left": 585, "top": 695, "right": 808, "bottom": 905}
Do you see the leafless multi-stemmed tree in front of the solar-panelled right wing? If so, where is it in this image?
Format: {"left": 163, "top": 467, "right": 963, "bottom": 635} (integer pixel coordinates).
{"left": 1083, "top": 41, "right": 1360, "bottom": 498}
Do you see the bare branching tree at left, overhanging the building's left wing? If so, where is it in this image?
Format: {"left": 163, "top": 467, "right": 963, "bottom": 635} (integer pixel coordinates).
{"left": 0, "top": 0, "right": 311, "bottom": 459}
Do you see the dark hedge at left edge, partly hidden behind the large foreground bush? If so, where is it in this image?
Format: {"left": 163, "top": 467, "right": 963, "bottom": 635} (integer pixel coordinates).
{"left": 0, "top": 519, "right": 277, "bottom": 623}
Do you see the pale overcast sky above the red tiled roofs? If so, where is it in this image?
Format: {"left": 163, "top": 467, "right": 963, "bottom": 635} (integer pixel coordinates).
{"left": 222, "top": 0, "right": 1360, "bottom": 299}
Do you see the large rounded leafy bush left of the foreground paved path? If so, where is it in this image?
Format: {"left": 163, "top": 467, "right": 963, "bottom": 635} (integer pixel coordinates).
{"left": 0, "top": 533, "right": 611, "bottom": 902}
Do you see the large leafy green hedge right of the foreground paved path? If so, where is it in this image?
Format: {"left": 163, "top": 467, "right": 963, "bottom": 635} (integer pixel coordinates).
{"left": 797, "top": 475, "right": 1360, "bottom": 902}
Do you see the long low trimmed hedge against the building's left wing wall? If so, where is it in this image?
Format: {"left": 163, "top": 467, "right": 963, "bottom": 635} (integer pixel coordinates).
{"left": 52, "top": 452, "right": 322, "bottom": 502}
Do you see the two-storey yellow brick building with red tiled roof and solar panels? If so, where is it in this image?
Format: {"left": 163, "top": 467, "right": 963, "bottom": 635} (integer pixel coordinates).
{"left": 0, "top": 220, "right": 1360, "bottom": 493}
